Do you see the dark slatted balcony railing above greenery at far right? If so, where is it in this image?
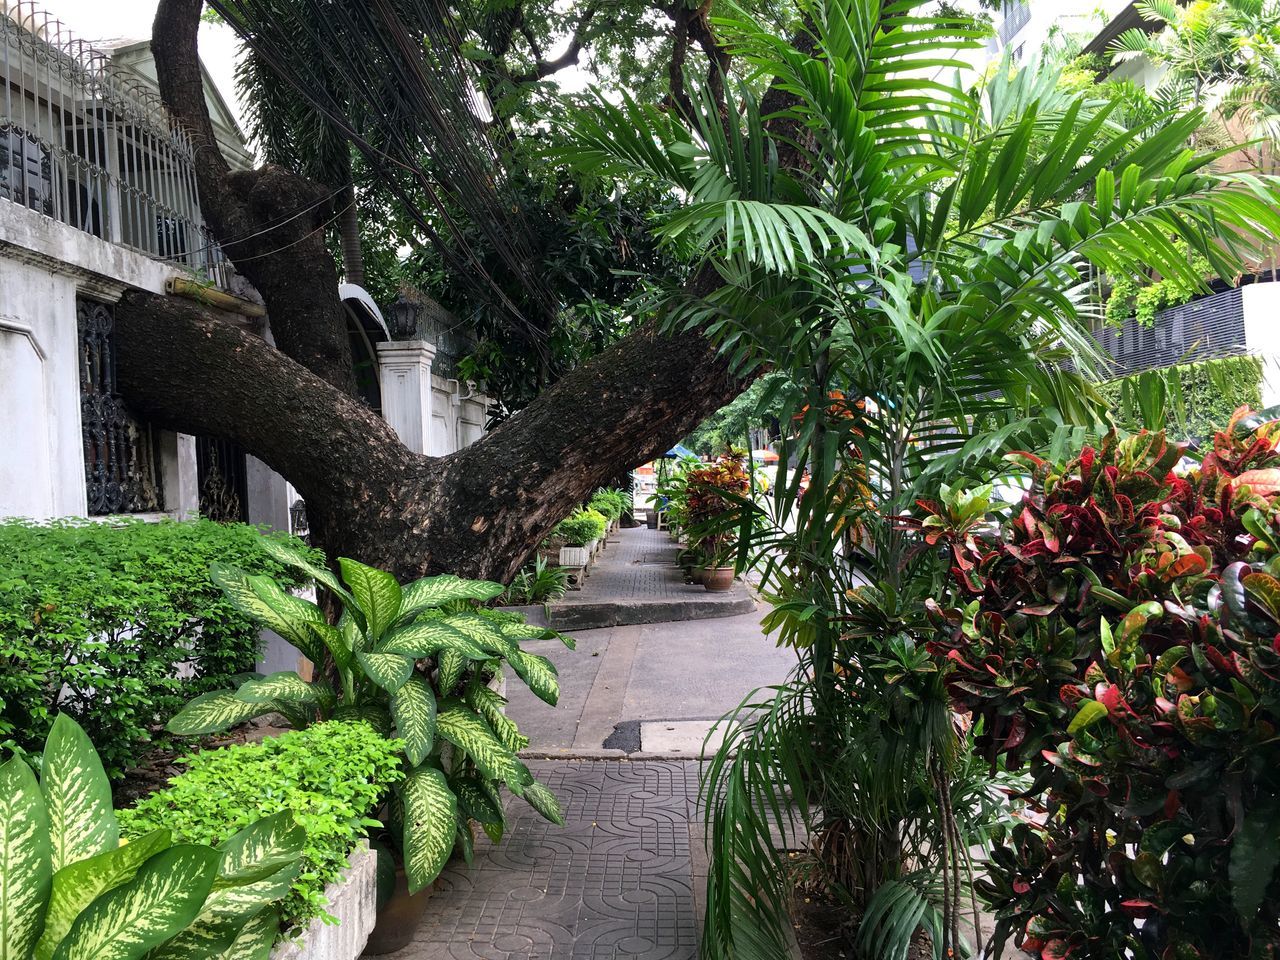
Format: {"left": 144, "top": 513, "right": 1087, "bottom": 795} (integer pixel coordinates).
{"left": 1094, "top": 287, "right": 1248, "bottom": 376}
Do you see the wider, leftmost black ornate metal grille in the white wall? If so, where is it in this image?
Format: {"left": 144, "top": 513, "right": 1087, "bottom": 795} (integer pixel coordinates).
{"left": 76, "top": 300, "right": 164, "bottom": 516}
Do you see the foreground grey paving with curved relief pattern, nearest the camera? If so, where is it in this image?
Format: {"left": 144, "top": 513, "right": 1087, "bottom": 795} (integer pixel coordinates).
{"left": 390, "top": 760, "right": 698, "bottom": 960}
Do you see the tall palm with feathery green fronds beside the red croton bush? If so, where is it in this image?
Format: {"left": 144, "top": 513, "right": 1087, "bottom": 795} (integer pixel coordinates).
{"left": 559, "top": 0, "right": 1280, "bottom": 957}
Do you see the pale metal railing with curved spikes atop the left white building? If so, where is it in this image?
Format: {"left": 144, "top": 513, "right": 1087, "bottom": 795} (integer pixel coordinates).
{"left": 0, "top": 0, "right": 228, "bottom": 287}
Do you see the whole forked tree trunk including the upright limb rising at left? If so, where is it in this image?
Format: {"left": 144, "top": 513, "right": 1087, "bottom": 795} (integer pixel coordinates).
{"left": 116, "top": 0, "right": 742, "bottom": 581}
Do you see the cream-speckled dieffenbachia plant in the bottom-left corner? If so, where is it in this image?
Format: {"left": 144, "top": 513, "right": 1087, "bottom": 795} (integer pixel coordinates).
{"left": 0, "top": 716, "right": 306, "bottom": 960}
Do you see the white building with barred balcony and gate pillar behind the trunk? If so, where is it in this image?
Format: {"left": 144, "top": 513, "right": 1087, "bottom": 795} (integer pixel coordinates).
{"left": 0, "top": 0, "right": 486, "bottom": 542}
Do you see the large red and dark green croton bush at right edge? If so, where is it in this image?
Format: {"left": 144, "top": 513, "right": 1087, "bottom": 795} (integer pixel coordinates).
{"left": 922, "top": 410, "right": 1280, "bottom": 960}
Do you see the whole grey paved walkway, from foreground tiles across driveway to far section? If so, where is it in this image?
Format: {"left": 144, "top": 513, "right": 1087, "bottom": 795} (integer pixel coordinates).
{"left": 373, "top": 531, "right": 795, "bottom": 960}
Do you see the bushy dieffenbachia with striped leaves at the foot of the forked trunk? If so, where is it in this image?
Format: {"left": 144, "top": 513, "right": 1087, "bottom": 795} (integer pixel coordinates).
{"left": 167, "top": 538, "right": 572, "bottom": 901}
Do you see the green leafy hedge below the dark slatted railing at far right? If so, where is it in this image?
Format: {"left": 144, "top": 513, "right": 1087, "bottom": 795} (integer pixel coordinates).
{"left": 1098, "top": 356, "right": 1262, "bottom": 440}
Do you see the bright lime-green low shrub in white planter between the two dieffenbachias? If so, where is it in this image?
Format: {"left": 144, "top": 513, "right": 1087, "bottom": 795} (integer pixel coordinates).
{"left": 116, "top": 721, "right": 402, "bottom": 927}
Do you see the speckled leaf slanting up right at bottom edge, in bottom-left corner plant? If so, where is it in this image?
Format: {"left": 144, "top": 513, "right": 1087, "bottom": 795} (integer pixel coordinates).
{"left": 54, "top": 844, "right": 220, "bottom": 960}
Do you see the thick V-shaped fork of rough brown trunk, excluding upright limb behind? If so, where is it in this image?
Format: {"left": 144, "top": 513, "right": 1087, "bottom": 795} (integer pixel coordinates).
{"left": 116, "top": 292, "right": 740, "bottom": 582}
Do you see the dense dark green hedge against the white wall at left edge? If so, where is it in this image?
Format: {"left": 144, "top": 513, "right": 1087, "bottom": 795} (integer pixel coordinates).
{"left": 0, "top": 520, "right": 318, "bottom": 778}
